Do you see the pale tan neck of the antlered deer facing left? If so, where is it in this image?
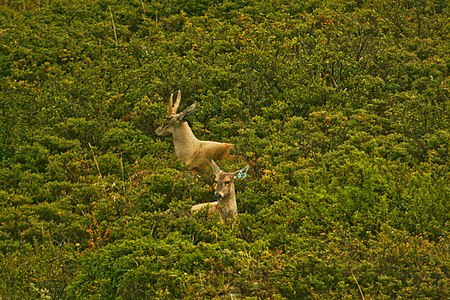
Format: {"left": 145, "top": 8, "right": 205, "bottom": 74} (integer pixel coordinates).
{"left": 172, "top": 122, "right": 200, "bottom": 163}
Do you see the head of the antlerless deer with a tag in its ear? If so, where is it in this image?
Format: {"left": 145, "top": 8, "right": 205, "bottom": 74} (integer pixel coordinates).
{"left": 211, "top": 160, "right": 249, "bottom": 201}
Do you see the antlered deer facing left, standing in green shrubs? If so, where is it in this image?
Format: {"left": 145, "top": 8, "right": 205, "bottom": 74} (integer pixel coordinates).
{"left": 155, "top": 90, "right": 234, "bottom": 170}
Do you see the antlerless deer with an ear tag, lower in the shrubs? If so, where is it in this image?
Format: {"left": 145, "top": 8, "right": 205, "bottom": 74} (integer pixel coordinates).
{"left": 191, "top": 160, "right": 249, "bottom": 223}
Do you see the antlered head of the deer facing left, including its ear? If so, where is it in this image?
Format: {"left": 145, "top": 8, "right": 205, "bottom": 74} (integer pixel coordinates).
{"left": 155, "top": 90, "right": 197, "bottom": 137}
